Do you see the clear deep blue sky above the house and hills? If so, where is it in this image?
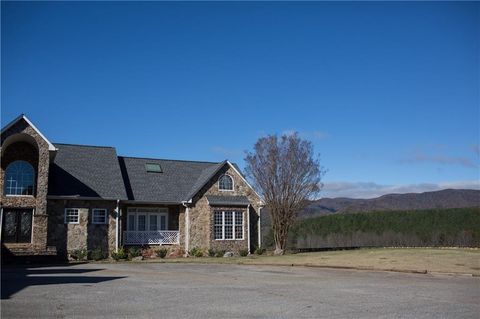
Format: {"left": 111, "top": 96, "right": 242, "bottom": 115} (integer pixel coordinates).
{"left": 1, "top": 2, "right": 480, "bottom": 197}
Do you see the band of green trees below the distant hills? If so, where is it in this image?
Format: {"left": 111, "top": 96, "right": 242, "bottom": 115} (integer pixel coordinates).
{"left": 264, "top": 207, "right": 480, "bottom": 249}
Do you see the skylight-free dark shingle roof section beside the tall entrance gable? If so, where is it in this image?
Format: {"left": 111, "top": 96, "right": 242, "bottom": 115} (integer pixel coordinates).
{"left": 48, "top": 144, "right": 127, "bottom": 199}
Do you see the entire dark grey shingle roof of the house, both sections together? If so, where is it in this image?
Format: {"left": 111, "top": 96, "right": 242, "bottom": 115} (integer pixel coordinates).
{"left": 48, "top": 144, "right": 248, "bottom": 205}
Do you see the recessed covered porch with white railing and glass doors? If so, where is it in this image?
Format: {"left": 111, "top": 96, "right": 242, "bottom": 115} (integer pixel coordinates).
{"left": 122, "top": 206, "right": 180, "bottom": 246}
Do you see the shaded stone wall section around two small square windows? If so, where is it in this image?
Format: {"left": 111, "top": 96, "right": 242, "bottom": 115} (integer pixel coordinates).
{"left": 47, "top": 199, "right": 117, "bottom": 255}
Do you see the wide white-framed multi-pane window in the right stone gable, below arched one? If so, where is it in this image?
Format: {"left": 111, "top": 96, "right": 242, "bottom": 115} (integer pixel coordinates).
{"left": 213, "top": 211, "right": 243, "bottom": 240}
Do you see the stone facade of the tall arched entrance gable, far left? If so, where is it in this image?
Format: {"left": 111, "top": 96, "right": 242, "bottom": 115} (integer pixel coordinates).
{"left": 0, "top": 119, "right": 50, "bottom": 253}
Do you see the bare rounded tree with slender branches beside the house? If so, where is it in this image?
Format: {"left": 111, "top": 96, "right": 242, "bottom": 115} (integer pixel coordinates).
{"left": 245, "top": 133, "right": 324, "bottom": 255}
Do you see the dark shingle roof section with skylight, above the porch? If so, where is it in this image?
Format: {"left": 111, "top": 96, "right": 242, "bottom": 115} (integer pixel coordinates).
{"left": 119, "top": 156, "right": 225, "bottom": 203}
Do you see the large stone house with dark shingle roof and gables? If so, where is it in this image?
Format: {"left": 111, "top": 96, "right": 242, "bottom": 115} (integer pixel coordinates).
{"left": 0, "top": 115, "right": 263, "bottom": 256}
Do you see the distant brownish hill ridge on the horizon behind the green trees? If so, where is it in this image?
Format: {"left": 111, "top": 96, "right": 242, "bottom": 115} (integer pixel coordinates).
{"left": 300, "top": 189, "right": 480, "bottom": 218}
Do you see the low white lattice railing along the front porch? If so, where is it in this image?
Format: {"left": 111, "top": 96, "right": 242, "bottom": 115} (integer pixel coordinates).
{"left": 123, "top": 230, "right": 180, "bottom": 245}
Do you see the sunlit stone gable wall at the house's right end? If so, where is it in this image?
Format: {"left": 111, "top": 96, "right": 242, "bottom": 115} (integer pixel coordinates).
{"left": 190, "top": 165, "right": 261, "bottom": 252}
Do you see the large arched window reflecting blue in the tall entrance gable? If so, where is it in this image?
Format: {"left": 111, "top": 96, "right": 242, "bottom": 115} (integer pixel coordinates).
{"left": 5, "top": 161, "right": 35, "bottom": 195}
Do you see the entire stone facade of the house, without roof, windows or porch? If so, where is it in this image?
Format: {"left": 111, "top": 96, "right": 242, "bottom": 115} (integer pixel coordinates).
{"left": 0, "top": 117, "right": 261, "bottom": 256}
